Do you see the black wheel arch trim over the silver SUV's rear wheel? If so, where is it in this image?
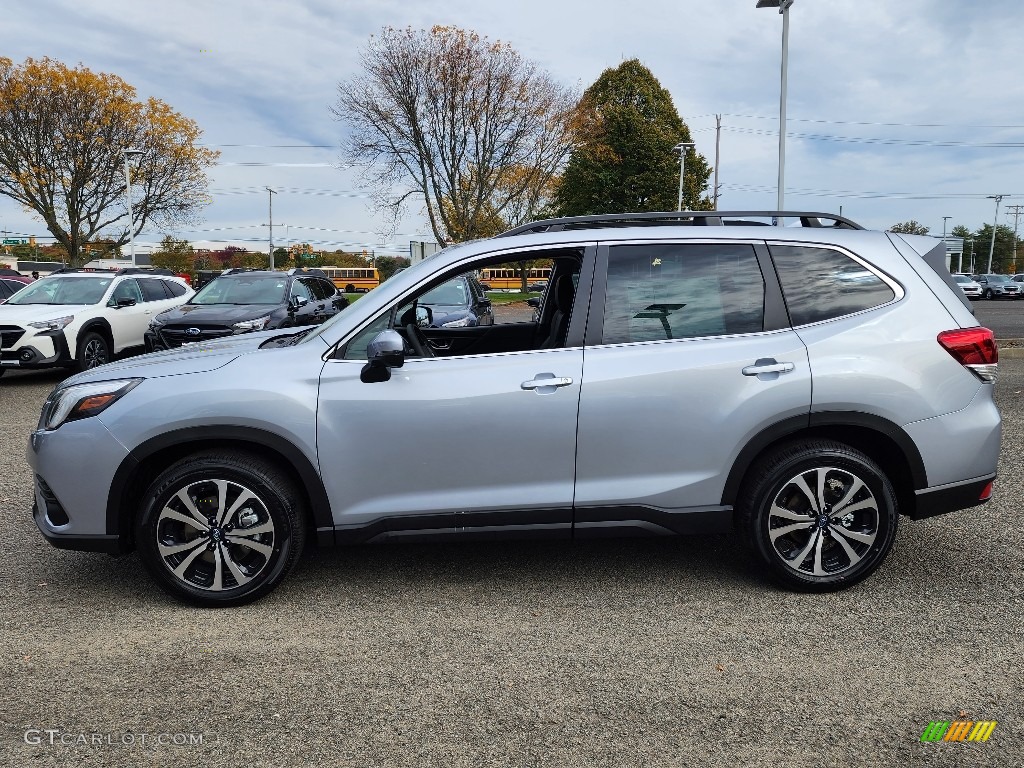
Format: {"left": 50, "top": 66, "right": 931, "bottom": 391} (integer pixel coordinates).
{"left": 722, "top": 411, "right": 928, "bottom": 505}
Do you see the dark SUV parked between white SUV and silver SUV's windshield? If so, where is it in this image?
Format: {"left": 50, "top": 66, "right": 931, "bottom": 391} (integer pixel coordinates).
{"left": 145, "top": 269, "right": 348, "bottom": 351}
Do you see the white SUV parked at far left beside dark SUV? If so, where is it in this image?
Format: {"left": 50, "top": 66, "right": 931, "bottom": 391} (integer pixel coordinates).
{"left": 0, "top": 268, "right": 195, "bottom": 376}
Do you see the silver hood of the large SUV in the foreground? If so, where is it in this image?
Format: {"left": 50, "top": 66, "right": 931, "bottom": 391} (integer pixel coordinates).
{"left": 63, "top": 331, "right": 281, "bottom": 385}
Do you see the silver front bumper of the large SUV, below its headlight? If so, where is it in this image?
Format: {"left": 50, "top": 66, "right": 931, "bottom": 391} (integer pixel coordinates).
{"left": 26, "top": 417, "right": 128, "bottom": 553}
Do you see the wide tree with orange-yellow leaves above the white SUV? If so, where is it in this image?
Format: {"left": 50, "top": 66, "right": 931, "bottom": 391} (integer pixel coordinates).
{"left": 0, "top": 57, "right": 219, "bottom": 263}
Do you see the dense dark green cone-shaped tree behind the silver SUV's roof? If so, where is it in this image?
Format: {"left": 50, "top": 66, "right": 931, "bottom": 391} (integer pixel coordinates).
{"left": 554, "top": 58, "right": 712, "bottom": 216}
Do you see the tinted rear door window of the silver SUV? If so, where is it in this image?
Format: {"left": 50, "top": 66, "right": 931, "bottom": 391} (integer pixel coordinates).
{"left": 602, "top": 243, "right": 765, "bottom": 344}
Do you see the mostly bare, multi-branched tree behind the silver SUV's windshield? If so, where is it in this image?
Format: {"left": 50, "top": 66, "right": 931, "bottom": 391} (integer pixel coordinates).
{"left": 332, "top": 27, "right": 575, "bottom": 247}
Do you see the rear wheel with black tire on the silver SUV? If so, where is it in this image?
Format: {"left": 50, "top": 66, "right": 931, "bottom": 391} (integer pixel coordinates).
{"left": 736, "top": 439, "right": 899, "bottom": 592}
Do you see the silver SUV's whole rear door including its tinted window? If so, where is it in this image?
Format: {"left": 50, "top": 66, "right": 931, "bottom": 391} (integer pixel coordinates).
{"left": 575, "top": 241, "right": 811, "bottom": 536}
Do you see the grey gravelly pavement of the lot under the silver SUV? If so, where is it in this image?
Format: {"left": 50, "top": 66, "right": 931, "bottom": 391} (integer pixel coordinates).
{"left": 0, "top": 359, "right": 1024, "bottom": 768}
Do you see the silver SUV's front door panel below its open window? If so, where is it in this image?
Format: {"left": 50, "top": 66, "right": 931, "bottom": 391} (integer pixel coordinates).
{"left": 317, "top": 348, "right": 583, "bottom": 540}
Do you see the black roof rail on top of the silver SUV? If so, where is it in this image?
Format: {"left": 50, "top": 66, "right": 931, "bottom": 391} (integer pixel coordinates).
{"left": 498, "top": 211, "right": 864, "bottom": 238}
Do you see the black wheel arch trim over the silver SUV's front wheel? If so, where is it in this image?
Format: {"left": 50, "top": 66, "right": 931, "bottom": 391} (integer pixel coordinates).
{"left": 106, "top": 425, "right": 334, "bottom": 548}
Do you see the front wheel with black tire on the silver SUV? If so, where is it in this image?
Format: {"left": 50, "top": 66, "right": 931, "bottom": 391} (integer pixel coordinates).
{"left": 135, "top": 451, "right": 306, "bottom": 607}
